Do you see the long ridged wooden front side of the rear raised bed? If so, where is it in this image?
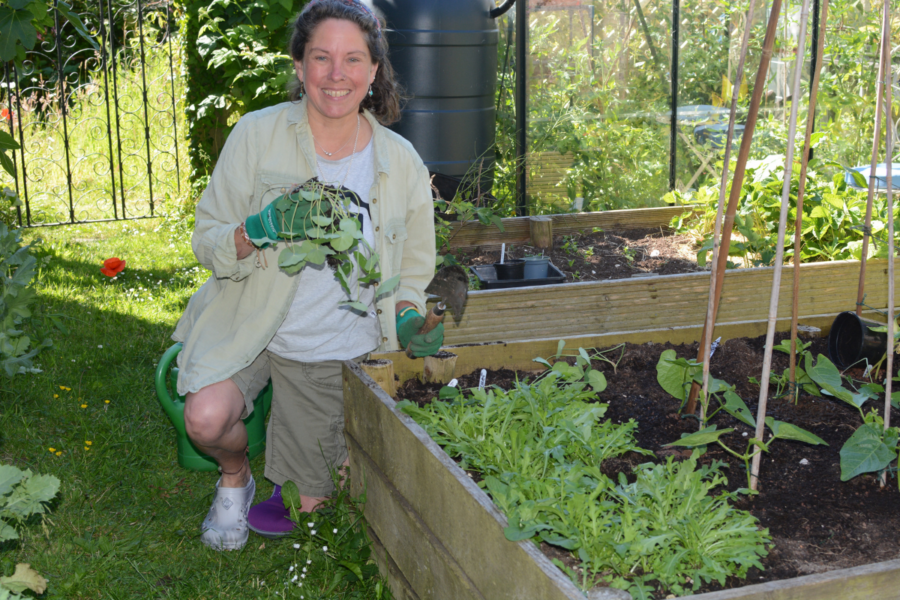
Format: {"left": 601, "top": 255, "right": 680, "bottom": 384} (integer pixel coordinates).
{"left": 445, "top": 260, "right": 900, "bottom": 345}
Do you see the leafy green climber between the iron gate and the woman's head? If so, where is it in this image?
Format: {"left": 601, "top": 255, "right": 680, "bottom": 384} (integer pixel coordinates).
{"left": 182, "top": 0, "right": 307, "bottom": 189}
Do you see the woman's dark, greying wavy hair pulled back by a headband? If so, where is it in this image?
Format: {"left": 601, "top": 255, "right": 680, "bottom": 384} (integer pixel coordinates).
{"left": 288, "top": 0, "right": 400, "bottom": 125}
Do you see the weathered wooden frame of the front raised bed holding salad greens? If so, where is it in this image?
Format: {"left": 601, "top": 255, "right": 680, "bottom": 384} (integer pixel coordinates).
{"left": 344, "top": 324, "right": 900, "bottom": 600}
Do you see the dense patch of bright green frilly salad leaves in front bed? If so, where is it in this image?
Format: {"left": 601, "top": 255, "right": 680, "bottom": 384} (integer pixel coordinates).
{"left": 398, "top": 349, "right": 770, "bottom": 597}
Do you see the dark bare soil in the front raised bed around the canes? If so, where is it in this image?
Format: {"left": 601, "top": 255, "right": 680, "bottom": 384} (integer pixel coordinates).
{"left": 397, "top": 335, "right": 900, "bottom": 591}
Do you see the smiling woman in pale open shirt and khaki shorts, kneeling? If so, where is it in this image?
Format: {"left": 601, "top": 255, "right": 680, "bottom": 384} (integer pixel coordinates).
{"left": 173, "top": 0, "right": 443, "bottom": 549}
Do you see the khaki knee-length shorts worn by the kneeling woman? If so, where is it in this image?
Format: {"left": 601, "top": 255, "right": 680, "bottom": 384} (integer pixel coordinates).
{"left": 231, "top": 350, "right": 366, "bottom": 497}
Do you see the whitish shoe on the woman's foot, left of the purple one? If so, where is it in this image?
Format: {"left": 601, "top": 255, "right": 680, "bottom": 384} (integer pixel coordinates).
{"left": 200, "top": 475, "right": 256, "bottom": 550}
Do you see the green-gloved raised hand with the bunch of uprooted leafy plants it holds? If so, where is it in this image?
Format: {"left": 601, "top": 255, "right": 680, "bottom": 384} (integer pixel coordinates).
{"left": 246, "top": 178, "right": 400, "bottom": 313}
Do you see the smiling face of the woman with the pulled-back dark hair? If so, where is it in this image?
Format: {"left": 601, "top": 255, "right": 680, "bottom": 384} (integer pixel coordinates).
{"left": 294, "top": 19, "right": 378, "bottom": 120}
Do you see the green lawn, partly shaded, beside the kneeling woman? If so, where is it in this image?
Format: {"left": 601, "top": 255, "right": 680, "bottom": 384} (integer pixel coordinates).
{"left": 0, "top": 219, "right": 388, "bottom": 599}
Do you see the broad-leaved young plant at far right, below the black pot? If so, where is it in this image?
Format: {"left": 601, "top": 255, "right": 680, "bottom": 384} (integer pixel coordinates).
{"left": 806, "top": 354, "right": 900, "bottom": 481}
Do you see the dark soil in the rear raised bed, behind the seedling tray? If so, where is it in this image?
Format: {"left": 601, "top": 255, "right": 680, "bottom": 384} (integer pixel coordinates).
{"left": 453, "top": 228, "right": 704, "bottom": 283}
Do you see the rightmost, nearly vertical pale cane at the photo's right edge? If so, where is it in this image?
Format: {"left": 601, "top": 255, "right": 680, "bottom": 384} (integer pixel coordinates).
{"left": 871, "top": 0, "right": 894, "bottom": 486}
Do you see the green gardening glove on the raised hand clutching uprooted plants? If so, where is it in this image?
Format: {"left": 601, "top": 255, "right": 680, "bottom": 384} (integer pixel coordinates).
{"left": 245, "top": 180, "right": 334, "bottom": 248}
